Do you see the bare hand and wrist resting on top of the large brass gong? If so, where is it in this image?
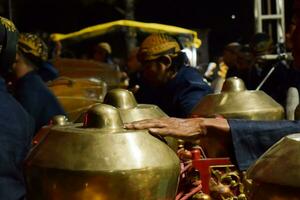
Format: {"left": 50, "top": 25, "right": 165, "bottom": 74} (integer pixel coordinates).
{"left": 125, "top": 117, "right": 232, "bottom": 157}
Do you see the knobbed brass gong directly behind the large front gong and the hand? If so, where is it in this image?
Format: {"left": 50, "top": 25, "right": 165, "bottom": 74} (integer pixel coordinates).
{"left": 104, "top": 89, "right": 178, "bottom": 151}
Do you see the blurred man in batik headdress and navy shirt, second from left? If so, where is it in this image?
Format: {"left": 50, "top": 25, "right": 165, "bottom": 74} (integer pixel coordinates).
{"left": 13, "top": 33, "right": 65, "bottom": 131}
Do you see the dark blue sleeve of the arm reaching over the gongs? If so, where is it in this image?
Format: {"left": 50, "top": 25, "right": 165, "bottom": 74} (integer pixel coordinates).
{"left": 228, "top": 120, "right": 300, "bottom": 170}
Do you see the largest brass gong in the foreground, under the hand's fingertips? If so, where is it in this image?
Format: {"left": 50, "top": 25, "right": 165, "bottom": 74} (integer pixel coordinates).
{"left": 24, "top": 105, "right": 180, "bottom": 200}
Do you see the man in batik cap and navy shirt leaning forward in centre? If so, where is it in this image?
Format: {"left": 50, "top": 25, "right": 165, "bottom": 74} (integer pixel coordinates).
{"left": 136, "top": 34, "right": 212, "bottom": 117}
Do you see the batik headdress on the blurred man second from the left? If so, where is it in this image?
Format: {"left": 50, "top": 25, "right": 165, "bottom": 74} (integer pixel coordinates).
{"left": 18, "top": 33, "right": 48, "bottom": 61}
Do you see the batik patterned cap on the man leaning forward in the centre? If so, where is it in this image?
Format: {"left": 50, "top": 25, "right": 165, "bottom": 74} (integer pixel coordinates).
{"left": 137, "top": 33, "right": 180, "bottom": 62}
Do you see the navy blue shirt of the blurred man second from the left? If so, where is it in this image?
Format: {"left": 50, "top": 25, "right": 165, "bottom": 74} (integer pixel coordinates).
{"left": 15, "top": 72, "right": 65, "bottom": 131}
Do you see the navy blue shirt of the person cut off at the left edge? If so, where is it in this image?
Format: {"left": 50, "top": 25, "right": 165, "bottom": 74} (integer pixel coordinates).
{"left": 0, "top": 78, "right": 34, "bottom": 200}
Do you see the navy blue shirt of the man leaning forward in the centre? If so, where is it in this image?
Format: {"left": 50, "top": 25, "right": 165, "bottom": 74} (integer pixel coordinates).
{"left": 136, "top": 66, "right": 212, "bottom": 117}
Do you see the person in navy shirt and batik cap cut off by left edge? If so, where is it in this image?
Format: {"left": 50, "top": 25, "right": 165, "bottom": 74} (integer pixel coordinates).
{"left": 0, "top": 17, "right": 34, "bottom": 200}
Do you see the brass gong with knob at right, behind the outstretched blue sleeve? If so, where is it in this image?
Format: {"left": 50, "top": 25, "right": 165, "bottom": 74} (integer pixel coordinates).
{"left": 192, "top": 77, "right": 284, "bottom": 120}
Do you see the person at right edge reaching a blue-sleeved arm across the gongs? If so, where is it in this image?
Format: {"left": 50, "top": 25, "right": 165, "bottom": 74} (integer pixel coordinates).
{"left": 126, "top": 0, "right": 300, "bottom": 170}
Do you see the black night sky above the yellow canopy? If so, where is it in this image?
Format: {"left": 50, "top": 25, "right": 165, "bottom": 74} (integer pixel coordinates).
{"left": 0, "top": 0, "right": 292, "bottom": 57}
